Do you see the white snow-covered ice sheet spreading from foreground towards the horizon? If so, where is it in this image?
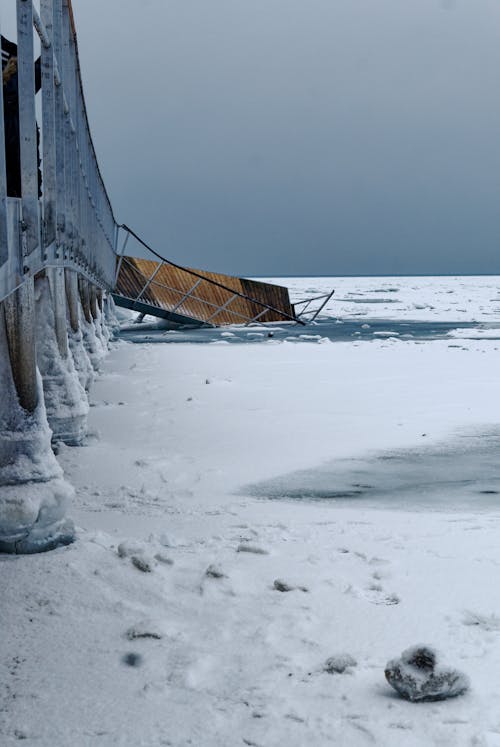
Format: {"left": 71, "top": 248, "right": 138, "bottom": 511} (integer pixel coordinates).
{"left": 0, "top": 277, "right": 500, "bottom": 747}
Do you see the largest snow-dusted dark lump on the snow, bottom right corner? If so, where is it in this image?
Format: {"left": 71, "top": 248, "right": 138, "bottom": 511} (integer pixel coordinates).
{"left": 385, "top": 646, "right": 469, "bottom": 703}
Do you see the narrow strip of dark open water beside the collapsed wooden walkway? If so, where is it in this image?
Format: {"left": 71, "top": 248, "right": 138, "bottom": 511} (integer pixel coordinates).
{"left": 120, "top": 317, "right": 500, "bottom": 345}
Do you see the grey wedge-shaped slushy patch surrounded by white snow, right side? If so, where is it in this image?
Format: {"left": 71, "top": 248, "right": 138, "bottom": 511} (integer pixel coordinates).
{"left": 241, "top": 429, "right": 500, "bottom": 510}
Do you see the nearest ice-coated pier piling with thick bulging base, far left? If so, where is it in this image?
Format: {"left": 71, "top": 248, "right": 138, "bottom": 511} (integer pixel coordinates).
{"left": 0, "top": 292, "right": 74, "bottom": 553}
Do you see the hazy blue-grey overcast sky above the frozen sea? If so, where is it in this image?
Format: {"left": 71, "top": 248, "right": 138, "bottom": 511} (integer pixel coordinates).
{"left": 2, "top": 0, "right": 500, "bottom": 275}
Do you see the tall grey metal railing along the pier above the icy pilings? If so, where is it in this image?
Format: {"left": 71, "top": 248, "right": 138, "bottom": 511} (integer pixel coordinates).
{"left": 0, "top": 0, "right": 117, "bottom": 301}
